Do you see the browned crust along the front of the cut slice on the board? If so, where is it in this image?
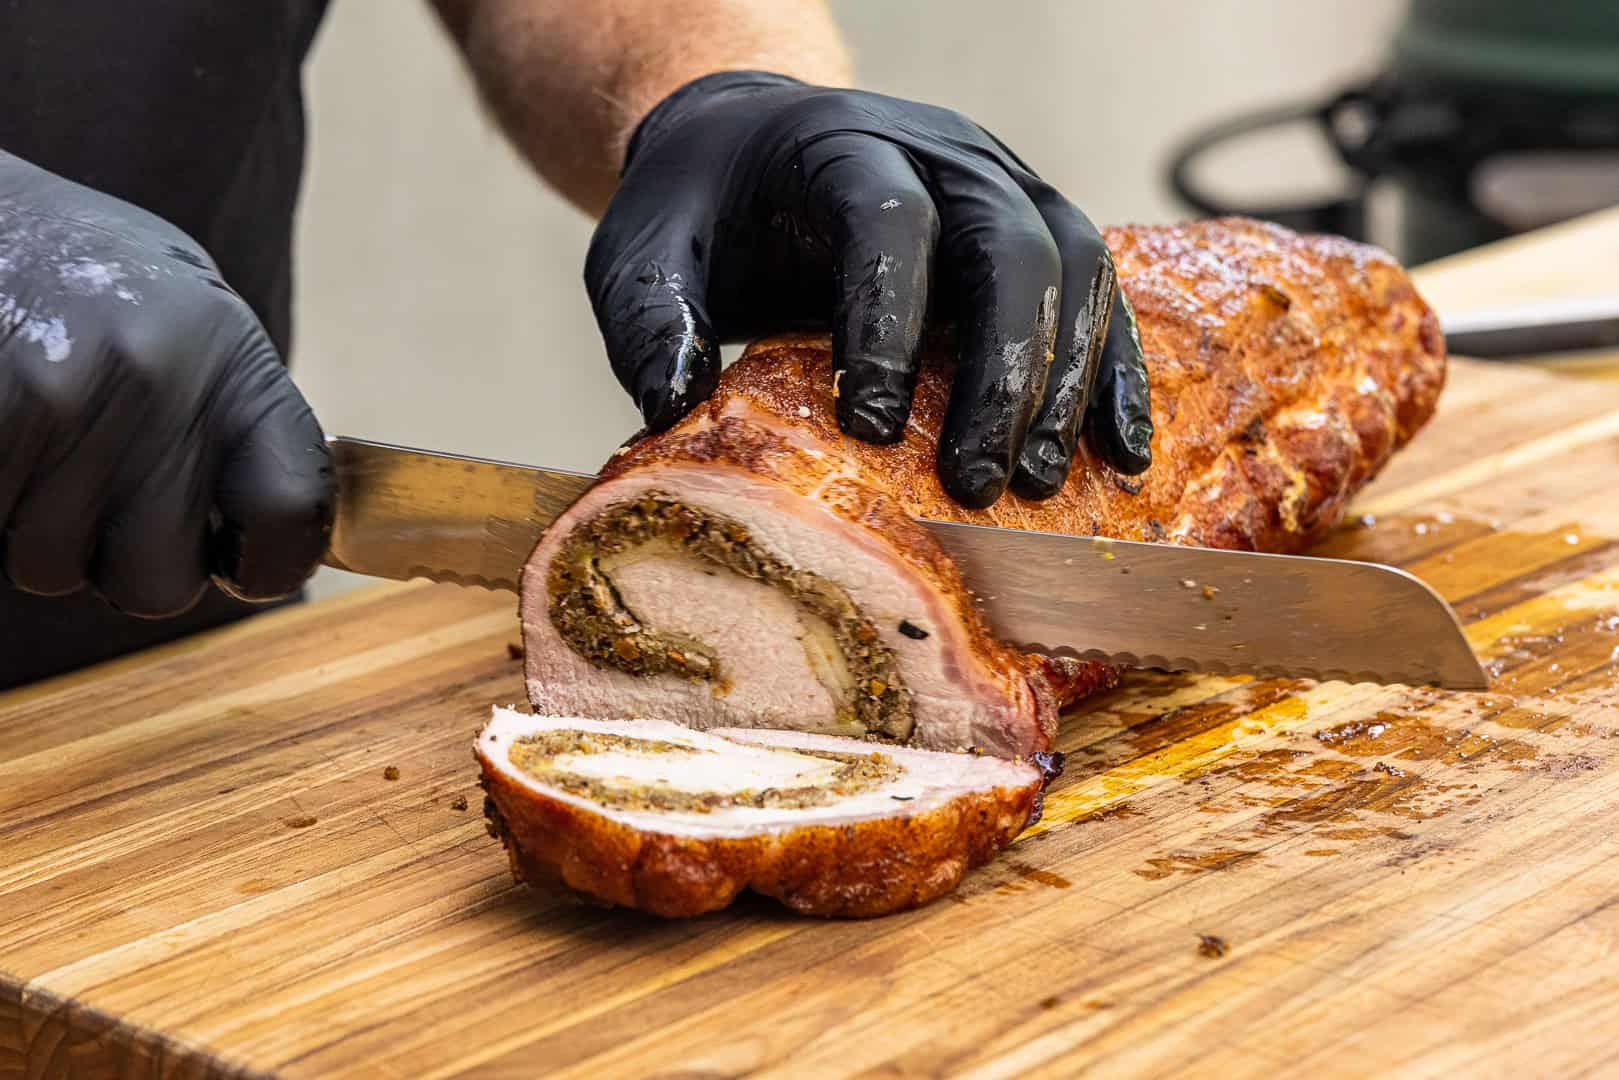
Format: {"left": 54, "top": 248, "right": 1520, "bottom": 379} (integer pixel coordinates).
{"left": 478, "top": 750, "right": 1043, "bottom": 918}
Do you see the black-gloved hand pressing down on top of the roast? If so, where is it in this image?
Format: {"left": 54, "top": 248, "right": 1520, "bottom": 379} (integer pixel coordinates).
{"left": 584, "top": 71, "right": 1153, "bottom": 507}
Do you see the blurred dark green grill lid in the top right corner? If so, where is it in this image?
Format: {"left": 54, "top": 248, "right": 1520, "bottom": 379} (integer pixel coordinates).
{"left": 1392, "top": 0, "right": 1619, "bottom": 96}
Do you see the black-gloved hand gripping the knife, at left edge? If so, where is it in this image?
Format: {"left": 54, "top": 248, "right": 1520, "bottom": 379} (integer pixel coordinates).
{"left": 0, "top": 154, "right": 334, "bottom": 617}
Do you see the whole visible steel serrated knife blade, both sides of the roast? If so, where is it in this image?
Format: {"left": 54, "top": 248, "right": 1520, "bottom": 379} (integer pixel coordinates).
{"left": 325, "top": 439, "right": 1488, "bottom": 690}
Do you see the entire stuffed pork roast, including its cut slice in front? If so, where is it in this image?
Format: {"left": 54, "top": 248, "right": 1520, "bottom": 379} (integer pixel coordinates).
{"left": 478, "top": 220, "right": 1444, "bottom": 916}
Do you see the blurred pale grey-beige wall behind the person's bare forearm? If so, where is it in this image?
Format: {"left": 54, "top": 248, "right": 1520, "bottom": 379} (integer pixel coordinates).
{"left": 295, "top": 0, "right": 1402, "bottom": 591}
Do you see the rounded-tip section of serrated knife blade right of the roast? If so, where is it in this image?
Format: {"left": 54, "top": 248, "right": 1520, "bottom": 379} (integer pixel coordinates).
{"left": 926, "top": 521, "right": 1488, "bottom": 690}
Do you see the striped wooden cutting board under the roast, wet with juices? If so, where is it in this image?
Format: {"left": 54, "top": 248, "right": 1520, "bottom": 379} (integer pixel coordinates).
{"left": 0, "top": 214, "right": 1619, "bottom": 1077}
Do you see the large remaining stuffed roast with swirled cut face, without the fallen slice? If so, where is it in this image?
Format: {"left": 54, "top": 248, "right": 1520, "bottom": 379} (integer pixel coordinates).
{"left": 521, "top": 220, "right": 1444, "bottom": 756}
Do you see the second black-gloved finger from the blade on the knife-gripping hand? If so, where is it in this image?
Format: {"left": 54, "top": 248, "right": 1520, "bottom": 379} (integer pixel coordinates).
{"left": 92, "top": 444, "right": 212, "bottom": 619}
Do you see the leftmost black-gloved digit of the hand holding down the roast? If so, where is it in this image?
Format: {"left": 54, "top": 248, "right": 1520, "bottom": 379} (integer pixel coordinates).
{"left": 584, "top": 200, "right": 720, "bottom": 432}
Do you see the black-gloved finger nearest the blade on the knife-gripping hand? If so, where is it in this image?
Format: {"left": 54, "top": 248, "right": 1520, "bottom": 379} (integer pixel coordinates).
{"left": 209, "top": 358, "right": 337, "bottom": 601}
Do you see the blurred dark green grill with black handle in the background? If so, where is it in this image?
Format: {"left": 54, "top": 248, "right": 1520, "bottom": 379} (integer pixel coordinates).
{"left": 1167, "top": 0, "right": 1619, "bottom": 264}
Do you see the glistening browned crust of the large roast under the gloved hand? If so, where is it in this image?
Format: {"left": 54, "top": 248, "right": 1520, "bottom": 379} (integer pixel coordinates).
{"left": 606, "top": 219, "right": 1446, "bottom": 718}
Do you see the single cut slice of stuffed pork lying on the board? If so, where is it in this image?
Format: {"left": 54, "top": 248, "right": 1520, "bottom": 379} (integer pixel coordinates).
{"left": 476, "top": 709, "right": 1044, "bottom": 916}
